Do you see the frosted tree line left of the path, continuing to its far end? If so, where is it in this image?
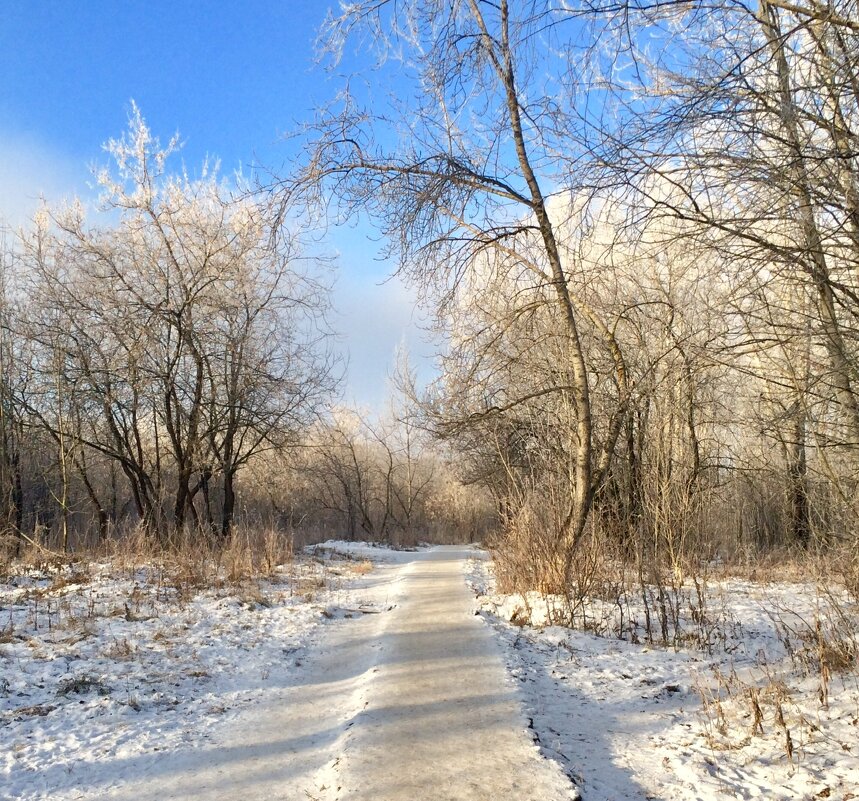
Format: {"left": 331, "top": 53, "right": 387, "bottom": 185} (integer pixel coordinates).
{"left": 0, "top": 107, "right": 489, "bottom": 553}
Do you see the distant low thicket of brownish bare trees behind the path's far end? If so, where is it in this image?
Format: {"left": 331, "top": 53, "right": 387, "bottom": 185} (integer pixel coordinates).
{"left": 242, "top": 396, "right": 498, "bottom": 546}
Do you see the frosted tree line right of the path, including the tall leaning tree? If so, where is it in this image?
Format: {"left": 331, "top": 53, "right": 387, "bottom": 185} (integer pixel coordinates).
{"left": 290, "top": 0, "right": 859, "bottom": 588}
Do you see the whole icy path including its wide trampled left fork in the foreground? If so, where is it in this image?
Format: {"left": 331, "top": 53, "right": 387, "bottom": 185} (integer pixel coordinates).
{"left": 93, "top": 547, "right": 577, "bottom": 801}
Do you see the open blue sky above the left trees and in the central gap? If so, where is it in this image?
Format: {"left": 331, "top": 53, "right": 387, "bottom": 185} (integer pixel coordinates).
{"left": 0, "top": 0, "right": 430, "bottom": 406}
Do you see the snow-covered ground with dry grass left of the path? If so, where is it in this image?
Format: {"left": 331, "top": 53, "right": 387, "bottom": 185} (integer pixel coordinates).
{"left": 0, "top": 553, "right": 369, "bottom": 801}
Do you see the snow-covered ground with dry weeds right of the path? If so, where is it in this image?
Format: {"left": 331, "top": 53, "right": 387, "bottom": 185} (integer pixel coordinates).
{"left": 469, "top": 560, "right": 859, "bottom": 801}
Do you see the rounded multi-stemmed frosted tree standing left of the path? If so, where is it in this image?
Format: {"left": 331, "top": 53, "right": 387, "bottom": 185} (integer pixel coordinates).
{"left": 20, "top": 108, "right": 335, "bottom": 538}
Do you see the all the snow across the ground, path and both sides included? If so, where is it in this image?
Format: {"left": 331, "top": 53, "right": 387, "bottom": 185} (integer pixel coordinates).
{"left": 0, "top": 541, "right": 859, "bottom": 801}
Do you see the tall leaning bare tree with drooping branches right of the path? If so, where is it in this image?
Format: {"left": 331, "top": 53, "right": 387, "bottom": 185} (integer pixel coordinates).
{"left": 288, "top": 0, "right": 640, "bottom": 580}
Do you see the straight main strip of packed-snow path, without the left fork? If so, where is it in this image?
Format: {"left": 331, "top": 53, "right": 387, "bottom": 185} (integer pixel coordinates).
{"left": 326, "top": 548, "right": 574, "bottom": 801}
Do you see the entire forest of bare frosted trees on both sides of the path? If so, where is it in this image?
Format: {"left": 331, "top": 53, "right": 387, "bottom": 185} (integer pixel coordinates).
{"left": 0, "top": 0, "right": 859, "bottom": 592}
